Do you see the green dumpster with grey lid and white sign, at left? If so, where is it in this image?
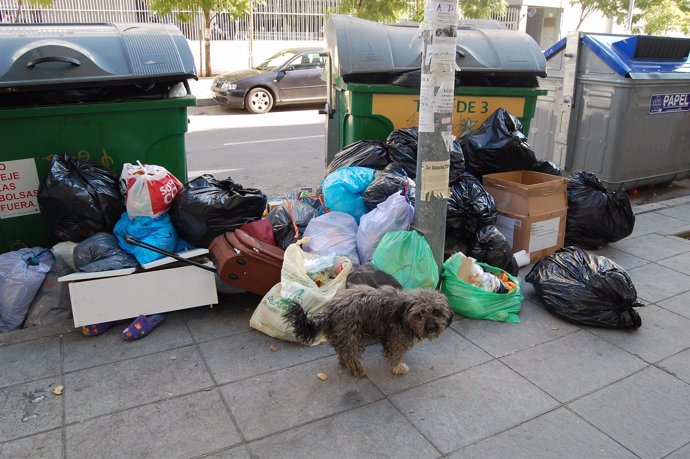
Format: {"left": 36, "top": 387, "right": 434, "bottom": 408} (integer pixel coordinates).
{"left": 0, "top": 24, "right": 196, "bottom": 253}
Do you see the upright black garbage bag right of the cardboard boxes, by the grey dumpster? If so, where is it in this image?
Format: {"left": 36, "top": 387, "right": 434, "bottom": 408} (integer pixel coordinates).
{"left": 565, "top": 172, "right": 635, "bottom": 249}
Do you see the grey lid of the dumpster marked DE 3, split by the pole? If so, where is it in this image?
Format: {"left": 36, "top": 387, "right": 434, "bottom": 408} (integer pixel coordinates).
{"left": 325, "top": 14, "right": 546, "bottom": 77}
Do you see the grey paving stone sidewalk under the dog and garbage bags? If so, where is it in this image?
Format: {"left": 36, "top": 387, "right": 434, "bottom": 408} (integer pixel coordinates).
{"left": 0, "top": 197, "right": 690, "bottom": 459}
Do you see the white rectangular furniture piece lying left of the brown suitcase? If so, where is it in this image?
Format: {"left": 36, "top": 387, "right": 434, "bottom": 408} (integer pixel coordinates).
{"left": 58, "top": 249, "right": 218, "bottom": 327}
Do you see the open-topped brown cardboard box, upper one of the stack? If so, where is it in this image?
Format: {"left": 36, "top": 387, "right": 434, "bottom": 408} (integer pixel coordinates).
{"left": 482, "top": 171, "right": 568, "bottom": 217}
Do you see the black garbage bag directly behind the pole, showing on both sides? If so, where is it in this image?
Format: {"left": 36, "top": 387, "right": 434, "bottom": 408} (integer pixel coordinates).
{"left": 386, "top": 128, "right": 465, "bottom": 184}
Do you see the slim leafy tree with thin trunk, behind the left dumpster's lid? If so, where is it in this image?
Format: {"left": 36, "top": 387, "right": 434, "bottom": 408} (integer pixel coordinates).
{"left": 151, "top": 0, "right": 252, "bottom": 76}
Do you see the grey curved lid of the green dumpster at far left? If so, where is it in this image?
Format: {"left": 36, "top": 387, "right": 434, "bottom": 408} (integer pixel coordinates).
{"left": 0, "top": 24, "right": 196, "bottom": 92}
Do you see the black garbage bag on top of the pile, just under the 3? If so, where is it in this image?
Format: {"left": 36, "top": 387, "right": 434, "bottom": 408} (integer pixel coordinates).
{"left": 460, "top": 108, "right": 538, "bottom": 178}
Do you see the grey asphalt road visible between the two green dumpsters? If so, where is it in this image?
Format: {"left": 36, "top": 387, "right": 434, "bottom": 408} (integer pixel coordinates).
{"left": 185, "top": 105, "right": 326, "bottom": 198}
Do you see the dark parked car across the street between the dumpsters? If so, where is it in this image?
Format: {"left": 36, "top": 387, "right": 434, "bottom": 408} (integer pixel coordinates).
{"left": 211, "top": 48, "right": 326, "bottom": 113}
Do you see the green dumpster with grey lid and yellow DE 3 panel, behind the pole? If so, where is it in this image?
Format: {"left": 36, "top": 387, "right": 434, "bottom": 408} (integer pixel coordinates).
{"left": 325, "top": 14, "right": 546, "bottom": 163}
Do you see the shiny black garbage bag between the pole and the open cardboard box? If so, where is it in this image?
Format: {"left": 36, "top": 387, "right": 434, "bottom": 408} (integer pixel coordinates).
{"left": 446, "top": 173, "right": 498, "bottom": 244}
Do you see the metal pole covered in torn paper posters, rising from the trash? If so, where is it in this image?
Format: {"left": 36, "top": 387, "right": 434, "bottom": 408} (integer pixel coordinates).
{"left": 414, "top": 0, "right": 458, "bottom": 272}
